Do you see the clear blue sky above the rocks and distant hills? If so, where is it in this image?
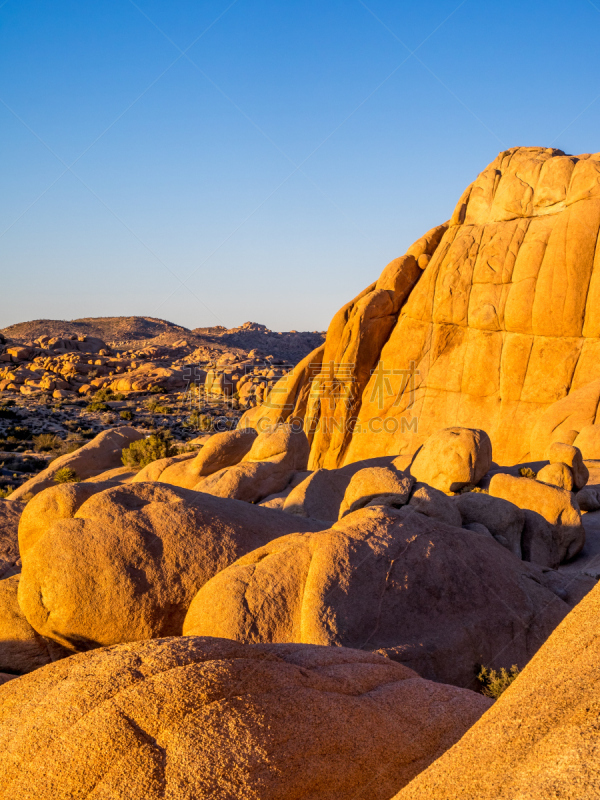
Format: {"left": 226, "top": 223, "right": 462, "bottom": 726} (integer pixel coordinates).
{"left": 0, "top": 0, "right": 600, "bottom": 330}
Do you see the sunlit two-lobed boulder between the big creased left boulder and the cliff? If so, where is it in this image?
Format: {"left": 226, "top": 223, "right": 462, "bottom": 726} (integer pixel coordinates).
{"left": 194, "top": 425, "right": 309, "bottom": 503}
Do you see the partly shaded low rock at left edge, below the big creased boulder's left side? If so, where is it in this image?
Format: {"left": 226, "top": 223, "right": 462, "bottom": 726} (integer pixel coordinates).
{"left": 0, "top": 575, "right": 68, "bottom": 675}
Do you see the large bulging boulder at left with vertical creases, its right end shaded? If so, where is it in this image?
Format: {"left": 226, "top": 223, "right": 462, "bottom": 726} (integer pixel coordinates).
{"left": 19, "top": 483, "right": 322, "bottom": 650}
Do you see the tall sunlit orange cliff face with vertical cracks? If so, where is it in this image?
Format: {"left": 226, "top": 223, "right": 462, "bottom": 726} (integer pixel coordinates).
{"left": 248, "top": 147, "right": 600, "bottom": 469}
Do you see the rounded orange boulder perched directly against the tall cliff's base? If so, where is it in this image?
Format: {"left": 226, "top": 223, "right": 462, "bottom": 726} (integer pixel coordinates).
{"left": 410, "top": 428, "right": 492, "bottom": 493}
